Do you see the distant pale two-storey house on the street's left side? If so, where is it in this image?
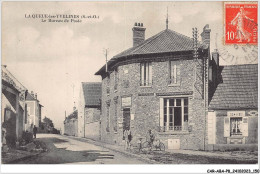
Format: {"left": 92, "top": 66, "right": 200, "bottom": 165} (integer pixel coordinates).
{"left": 25, "top": 91, "right": 43, "bottom": 130}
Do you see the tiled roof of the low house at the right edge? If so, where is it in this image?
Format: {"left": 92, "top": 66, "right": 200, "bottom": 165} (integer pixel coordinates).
{"left": 209, "top": 64, "right": 258, "bottom": 109}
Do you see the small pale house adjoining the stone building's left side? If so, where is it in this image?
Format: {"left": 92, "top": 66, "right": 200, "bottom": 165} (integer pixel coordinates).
{"left": 78, "top": 82, "right": 101, "bottom": 140}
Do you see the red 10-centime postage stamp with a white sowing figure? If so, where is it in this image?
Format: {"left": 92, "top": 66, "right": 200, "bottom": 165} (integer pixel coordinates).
{"left": 224, "top": 2, "right": 258, "bottom": 44}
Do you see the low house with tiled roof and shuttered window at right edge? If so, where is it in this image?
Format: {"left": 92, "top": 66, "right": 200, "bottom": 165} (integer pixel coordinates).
{"left": 208, "top": 62, "right": 258, "bottom": 150}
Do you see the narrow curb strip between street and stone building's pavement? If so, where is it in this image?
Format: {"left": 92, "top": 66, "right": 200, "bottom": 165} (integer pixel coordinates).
{"left": 62, "top": 135, "right": 161, "bottom": 164}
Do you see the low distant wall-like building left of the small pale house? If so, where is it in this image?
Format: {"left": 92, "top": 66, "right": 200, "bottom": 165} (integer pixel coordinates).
{"left": 64, "top": 108, "right": 78, "bottom": 136}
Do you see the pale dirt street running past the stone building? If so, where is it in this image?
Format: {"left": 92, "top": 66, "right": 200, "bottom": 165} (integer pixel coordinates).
{"left": 17, "top": 134, "right": 144, "bottom": 164}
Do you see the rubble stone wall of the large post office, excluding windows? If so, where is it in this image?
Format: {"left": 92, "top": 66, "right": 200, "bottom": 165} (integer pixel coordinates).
{"left": 101, "top": 55, "right": 206, "bottom": 149}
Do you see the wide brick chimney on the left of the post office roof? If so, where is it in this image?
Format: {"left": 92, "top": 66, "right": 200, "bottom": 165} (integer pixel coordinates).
{"left": 132, "top": 22, "right": 146, "bottom": 47}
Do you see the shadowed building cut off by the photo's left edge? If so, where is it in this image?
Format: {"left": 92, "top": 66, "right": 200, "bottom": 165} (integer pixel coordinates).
{"left": 1, "top": 66, "right": 27, "bottom": 143}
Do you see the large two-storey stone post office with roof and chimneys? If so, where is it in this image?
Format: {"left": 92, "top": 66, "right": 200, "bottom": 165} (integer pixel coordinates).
{"left": 95, "top": 23, "right": 211, "bottom": 150}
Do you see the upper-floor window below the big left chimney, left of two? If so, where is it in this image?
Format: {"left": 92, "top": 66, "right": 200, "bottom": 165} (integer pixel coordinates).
{"left": 140, "top": 62, "right": 152, "bottom": 86}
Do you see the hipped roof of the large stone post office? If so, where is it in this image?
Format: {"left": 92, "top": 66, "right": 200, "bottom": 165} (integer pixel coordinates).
{"left": 95, "top": 29, "right": 205, "bottom": 75}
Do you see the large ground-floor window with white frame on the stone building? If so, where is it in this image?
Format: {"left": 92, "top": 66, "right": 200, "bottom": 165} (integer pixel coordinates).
{"left": 161, "top": 98, "right": 188, "bottom": 131}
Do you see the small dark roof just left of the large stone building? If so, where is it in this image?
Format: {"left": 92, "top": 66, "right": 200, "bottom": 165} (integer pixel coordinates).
{"left": 82, "top": 82, "right": 102, "bottom": 106}
